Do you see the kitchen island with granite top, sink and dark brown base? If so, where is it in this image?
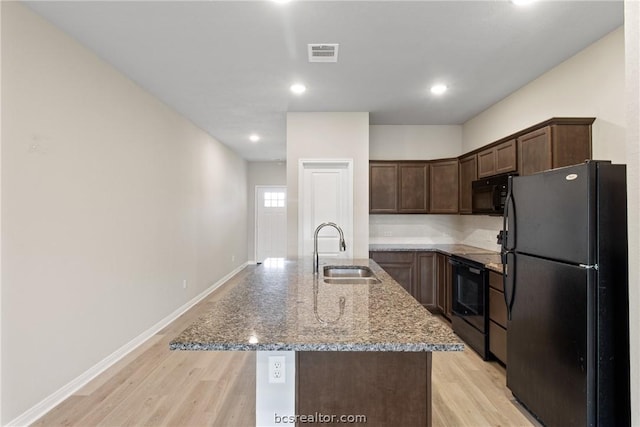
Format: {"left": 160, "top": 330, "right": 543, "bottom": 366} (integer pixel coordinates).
{"left": 170, "top": 258, "right": 463, "bottom": 426}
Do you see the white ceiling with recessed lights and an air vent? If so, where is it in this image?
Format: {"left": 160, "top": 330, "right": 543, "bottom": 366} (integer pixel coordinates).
{"left": 22, "top": 0, "right": 623, "bottom": 160}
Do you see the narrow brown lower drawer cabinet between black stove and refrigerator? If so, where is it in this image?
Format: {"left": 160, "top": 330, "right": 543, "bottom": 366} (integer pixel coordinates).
{"left": 489, "top": 271, "right": 507, "bottom": 365}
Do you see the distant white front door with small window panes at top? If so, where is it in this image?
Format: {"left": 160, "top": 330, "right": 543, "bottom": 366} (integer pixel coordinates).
{"left": 256, "top": 186, "right": 287, "bottom": 262}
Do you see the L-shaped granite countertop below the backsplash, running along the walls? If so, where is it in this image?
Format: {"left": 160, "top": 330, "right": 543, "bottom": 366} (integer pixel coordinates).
{"left": 369, "top": 243, "right": 502, "bottom": 274}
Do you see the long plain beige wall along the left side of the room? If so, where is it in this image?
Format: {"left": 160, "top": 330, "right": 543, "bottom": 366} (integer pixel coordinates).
{"left": 1, "top": 2, "right": 247, "bottom": 424}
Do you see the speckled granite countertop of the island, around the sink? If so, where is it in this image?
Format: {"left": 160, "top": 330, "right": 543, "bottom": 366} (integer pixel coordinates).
{"left": 170, "top": 258, "right": 464, "bottom": 351}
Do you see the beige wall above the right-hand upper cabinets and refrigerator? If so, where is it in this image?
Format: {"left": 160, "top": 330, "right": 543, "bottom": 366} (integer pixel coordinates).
{"left": 462, "top": 28, "right": 626, "bottom": 163}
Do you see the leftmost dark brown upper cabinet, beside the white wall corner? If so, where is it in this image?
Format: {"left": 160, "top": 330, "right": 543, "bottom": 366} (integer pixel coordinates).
{"left": 369, "top": 162, "right": 398, "bottom": 213}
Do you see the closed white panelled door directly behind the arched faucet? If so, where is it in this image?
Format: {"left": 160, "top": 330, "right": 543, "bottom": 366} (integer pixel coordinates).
{"left": 298, "top": 160, "right": 353, "bottom": 258}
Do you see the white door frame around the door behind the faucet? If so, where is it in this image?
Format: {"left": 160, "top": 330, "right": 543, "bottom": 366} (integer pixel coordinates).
{"left": 298, "top": 158, "right": 354, "bottom": 257}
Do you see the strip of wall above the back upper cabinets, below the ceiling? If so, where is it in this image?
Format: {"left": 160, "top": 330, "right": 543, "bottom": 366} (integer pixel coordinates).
{"left": 369, "top": 125, "right": 462, "bottom": 160}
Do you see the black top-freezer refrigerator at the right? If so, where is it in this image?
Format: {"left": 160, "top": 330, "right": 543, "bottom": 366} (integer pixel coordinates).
{"left": 502, "top": 161, "right": 631, "bottom": 427}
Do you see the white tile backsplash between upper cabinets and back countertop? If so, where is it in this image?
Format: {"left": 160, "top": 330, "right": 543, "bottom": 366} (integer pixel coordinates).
{"left": 369, "top": 215, "right": 502, "bottom": 251}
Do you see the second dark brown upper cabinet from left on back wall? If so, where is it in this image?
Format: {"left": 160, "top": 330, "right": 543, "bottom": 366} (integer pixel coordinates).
{"left": 398, "top": 162, "right": 429, "bottom": 213}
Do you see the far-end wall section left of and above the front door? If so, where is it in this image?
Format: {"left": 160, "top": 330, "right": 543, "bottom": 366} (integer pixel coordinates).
{"left": 247, "top": 162, "right": 287, "bottom": 262}
